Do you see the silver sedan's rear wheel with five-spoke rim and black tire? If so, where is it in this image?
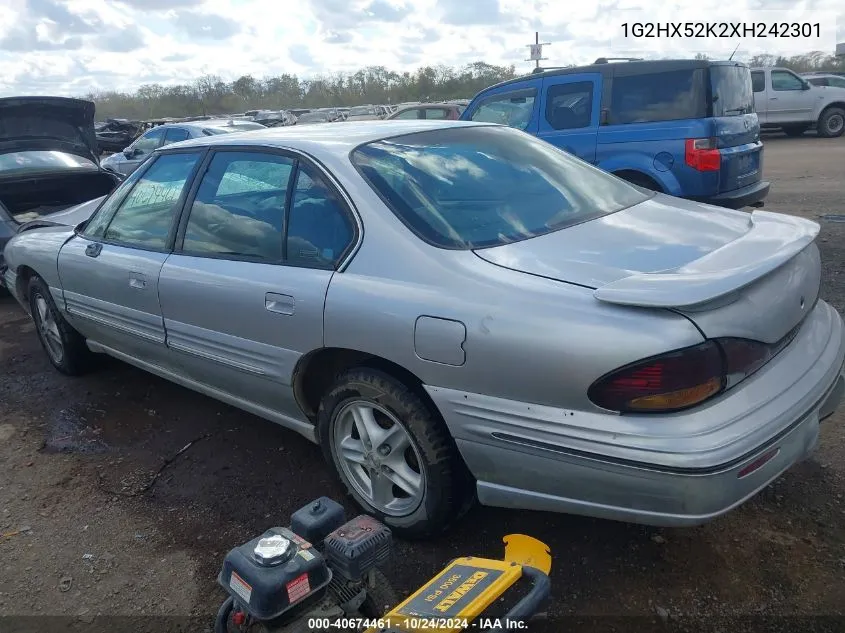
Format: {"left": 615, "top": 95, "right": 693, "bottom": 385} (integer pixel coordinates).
{"left": 317, "top": 368, "right": 472, "bottom": 538}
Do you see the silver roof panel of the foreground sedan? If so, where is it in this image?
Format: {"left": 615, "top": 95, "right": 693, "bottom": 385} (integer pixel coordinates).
{"left": 156, "top": 119, "right": 493, "bottom": 156}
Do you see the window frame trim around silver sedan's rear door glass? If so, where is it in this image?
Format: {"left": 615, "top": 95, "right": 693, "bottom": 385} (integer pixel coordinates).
{"left": 170, "top": 145, "right": 364, "bottom": 272}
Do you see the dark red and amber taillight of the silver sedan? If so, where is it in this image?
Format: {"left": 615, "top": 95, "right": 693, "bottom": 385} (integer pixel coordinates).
{"left": 587, "top": 338, "right": 791, "bottom": 413}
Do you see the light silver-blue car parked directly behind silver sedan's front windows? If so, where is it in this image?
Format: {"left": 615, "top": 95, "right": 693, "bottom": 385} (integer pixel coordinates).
{"left": 102, "top": 119, "right": 266, "bottom": 176}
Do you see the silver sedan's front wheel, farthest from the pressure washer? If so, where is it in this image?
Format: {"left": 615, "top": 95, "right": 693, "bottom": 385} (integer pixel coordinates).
{"left": 28, "top": 275, "right": 93, "bottom": 376}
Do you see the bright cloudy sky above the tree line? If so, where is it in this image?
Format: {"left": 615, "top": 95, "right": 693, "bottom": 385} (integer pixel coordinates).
{"left": 0, "top": 0, "right": 845, "bottom": 96}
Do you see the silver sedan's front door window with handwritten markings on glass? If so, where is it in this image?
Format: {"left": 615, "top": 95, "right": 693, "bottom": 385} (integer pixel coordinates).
{"left": 104, "top": 153, "right": 200, "bottom": 249}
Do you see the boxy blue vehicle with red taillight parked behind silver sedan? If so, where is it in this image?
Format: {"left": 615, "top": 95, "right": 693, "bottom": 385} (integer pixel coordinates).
{"left": 461, "top": 59, "right": 769, "bottom": 209}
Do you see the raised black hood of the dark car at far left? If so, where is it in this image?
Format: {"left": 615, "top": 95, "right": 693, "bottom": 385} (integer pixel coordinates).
{"left": 0, "top": 97, "right": 99, "bottom": 164}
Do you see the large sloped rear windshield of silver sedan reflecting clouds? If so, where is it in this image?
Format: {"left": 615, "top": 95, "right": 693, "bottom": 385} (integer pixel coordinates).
{"left": 352, "top": 126, "right": 649, "bottom": 249}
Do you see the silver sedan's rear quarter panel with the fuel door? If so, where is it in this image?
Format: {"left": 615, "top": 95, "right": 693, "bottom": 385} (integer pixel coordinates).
{"left": 324, "top": 169, "right": 702, "bottom": 410}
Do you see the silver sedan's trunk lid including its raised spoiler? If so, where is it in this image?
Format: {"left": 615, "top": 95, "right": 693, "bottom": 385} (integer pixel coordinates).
{"left": 475, "top": 195, "right": 821, "bottom": 343}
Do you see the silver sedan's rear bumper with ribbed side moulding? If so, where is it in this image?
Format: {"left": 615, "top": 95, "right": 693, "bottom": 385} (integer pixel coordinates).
{"left": 428, "top": 302, "right": 845, "bottom": 526}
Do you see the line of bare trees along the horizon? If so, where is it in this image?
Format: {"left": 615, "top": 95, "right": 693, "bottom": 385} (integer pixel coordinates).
{"left": 86, "top": 52, "right": 845, "bottom": 120}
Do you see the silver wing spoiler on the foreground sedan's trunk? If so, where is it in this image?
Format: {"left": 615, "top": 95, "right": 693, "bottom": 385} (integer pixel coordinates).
{"left": 593, "top": 211, "right": 820, "bottom": 308}
